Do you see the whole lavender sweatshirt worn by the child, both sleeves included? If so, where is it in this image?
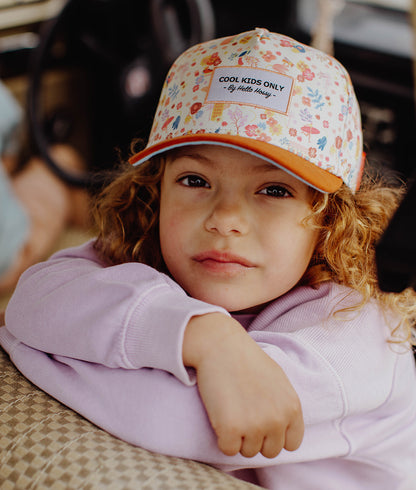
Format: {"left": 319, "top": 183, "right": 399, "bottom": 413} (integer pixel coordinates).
{"left": 0, "top": 242, "right": 416, "bottom": 490}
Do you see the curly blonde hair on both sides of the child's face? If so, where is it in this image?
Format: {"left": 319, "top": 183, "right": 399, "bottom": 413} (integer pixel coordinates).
{"left": 95, "top": 157, "right": 416, "bottom": 341}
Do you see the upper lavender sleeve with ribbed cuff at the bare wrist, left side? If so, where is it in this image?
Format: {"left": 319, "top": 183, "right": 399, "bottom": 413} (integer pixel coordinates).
{"left": 6, "top": 242, "right": 228, "bottom": 384}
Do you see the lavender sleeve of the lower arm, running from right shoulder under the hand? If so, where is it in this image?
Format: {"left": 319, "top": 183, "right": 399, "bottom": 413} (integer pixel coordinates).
{"left": 0, "top": 288, "right": 416, "bottom": 471}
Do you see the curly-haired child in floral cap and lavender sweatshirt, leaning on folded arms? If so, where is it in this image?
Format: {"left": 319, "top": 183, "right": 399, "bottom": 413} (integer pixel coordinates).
{"left": 0, "top": 29, "right": 416, "bottom": 490}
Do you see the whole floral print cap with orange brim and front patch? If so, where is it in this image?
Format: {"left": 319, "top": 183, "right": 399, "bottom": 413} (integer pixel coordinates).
{"left": 130, "top": 28, "right": 364, "bottom": 192}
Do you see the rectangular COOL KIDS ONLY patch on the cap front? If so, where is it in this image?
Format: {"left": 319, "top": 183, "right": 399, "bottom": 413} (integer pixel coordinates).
{"left": 206, "top": 66, "right": 293, "bottom": 114}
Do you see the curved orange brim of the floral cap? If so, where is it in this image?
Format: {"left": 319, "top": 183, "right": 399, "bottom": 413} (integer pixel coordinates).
{"left": 130, "top": 133, "right": 342, "bottom": 192}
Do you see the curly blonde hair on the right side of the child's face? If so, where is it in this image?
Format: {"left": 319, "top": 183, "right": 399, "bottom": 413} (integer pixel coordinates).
{"left": 302, "top": 175, "right": 416, "bottom": 344}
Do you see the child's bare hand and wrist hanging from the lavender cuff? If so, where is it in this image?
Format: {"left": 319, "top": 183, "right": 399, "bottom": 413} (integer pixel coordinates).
{"left": 183, "top": 313, "right": 304, "bottom": 458}
